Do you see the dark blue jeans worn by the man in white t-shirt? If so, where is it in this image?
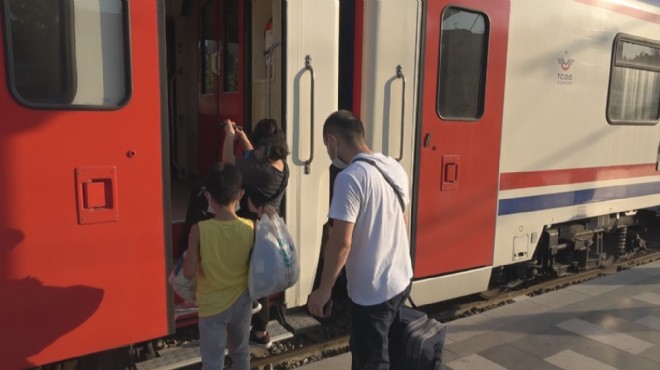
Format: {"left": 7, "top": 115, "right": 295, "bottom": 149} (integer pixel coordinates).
{"left": 350, "top": 285, "right": 411, "bottom": 370}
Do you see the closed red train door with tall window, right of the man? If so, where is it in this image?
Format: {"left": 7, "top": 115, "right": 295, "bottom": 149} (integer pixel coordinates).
{"left": 413, "top": 0, "right": 509, "bottom": 278}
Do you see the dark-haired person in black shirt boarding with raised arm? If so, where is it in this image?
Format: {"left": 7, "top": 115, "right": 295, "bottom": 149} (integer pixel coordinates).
{"left": 221, "top": 119, "right": 289, "bottom": 348}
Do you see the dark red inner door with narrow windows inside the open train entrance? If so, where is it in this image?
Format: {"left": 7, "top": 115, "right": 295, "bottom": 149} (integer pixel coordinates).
{"left": 198, "top": 0, "right": 246, "bottom": 176}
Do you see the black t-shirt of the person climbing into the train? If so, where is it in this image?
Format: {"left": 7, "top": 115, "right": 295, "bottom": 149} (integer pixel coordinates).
{"left": 236, "top": 153, "right": 289, "bottom": 219}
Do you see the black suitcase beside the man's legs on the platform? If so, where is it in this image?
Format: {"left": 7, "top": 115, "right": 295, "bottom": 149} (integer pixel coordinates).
{"left": 389, "top": 306, "right": 447, "bottom": 370}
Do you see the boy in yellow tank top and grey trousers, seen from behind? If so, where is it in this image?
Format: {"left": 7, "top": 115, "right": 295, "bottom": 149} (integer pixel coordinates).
{"left": 183, "top": 164, "right": 254, "bottom": 370}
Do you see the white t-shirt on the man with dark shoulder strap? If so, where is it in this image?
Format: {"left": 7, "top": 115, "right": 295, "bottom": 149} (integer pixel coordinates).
{"left": 328, "top": 153, "right": 412, "bottom": 306}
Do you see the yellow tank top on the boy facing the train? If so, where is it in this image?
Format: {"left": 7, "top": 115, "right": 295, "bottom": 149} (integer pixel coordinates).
{"left": 197, "top": 218, "right": 254, "bottom": 317}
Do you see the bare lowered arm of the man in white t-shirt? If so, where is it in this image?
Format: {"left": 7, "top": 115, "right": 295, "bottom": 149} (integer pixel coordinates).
{"left": 307, "top": 220, "right": 355, "bottom": 317}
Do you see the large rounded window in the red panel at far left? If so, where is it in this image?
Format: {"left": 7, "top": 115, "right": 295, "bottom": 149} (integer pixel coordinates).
{"left": 4, "top": 0, "right": 130, "bottom": 109}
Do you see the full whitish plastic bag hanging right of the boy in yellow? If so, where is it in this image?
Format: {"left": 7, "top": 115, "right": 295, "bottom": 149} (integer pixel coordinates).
{"left": 248, "top": 214, "right": 300, "bottom": 299}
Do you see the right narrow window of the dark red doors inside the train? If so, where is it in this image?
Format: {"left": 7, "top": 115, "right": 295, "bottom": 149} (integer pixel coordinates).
{"left": 222, "top": 0, "right": 239, "bottom": 92}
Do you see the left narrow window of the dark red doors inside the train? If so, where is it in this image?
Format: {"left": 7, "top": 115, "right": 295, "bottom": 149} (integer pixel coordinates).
{"left": 199, "top": 1, "right": 218, "bottom": 95}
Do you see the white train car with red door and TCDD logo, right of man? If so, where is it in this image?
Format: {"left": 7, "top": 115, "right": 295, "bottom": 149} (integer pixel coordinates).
{"left": 359, "top": 0, "right": 660, "bottom": 304}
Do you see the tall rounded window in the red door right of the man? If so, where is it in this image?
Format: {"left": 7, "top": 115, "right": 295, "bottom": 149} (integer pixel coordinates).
{"left": 437, "top": 7, "right": 489, "bottom": 121}
